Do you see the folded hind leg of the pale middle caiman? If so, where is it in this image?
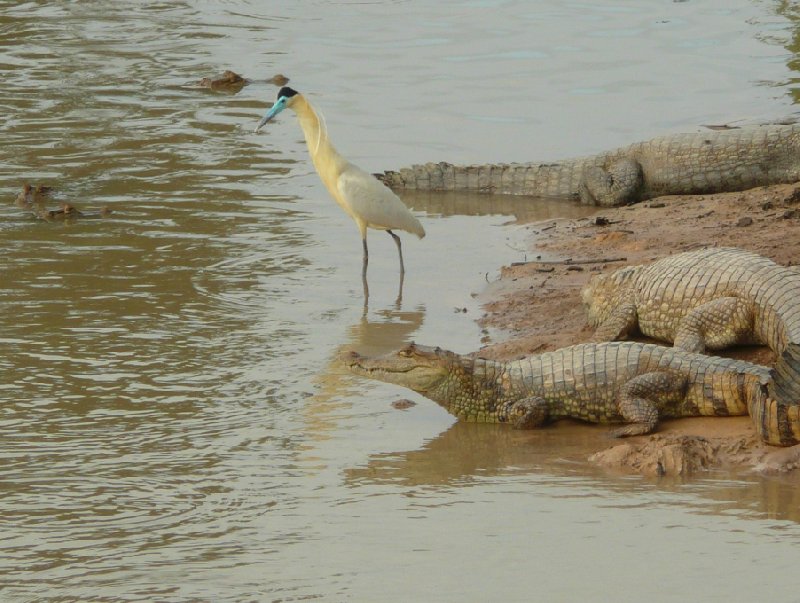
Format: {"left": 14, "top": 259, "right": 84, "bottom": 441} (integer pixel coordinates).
{"left": 674, "top": 297, "right": 754, "bottom": 353}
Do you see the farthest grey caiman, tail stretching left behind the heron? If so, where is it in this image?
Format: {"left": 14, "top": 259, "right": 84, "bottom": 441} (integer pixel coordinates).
{"left": 375, "top": 125, "right": 800, "bottom": 206}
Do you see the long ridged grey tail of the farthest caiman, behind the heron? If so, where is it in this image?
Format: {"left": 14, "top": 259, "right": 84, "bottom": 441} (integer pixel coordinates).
{"left": 374, "top": 160, "right": 583, "bottom": 199}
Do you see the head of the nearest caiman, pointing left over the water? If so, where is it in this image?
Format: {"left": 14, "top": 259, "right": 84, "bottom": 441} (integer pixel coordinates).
{"left": 344, "top": 343, "right": 459, "bottom": 395}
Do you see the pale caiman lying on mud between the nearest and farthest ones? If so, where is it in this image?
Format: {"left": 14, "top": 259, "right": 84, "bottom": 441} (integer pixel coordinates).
{"left": 582, "top": 247, "right": 800, "bottom": 446}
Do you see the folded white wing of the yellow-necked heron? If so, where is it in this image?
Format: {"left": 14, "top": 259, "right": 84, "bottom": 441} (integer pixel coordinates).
{"left": 337, "top": 164, "right": 424, "bottom": 236}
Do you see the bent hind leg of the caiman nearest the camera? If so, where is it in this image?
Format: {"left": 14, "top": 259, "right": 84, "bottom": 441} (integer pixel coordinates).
{"left": 611, "top": 371, "right": 688, "bottom": 438}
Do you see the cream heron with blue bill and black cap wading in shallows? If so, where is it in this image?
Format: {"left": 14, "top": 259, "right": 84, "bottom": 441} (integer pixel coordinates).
{"left": 255, "top": 86, "right": 425, "bottom": 282}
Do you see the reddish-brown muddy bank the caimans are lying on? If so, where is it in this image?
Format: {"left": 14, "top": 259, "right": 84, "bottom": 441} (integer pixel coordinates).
{"left": 480, "top": 184, "right": 800, "bottom": 475}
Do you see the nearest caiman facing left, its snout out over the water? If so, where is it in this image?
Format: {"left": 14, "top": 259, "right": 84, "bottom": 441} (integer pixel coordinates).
{"left": 344, "top": 342, "right": 776, "bottom": 437}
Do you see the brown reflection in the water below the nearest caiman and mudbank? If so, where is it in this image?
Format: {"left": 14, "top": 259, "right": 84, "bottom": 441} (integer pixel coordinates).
{"left": 345, "top": 421, "right": 800, "bottom": 522}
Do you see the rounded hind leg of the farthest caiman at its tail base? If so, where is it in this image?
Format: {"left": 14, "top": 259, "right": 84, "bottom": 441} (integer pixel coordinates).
{"left": 580, "top": 159, "right": 644, "bottom": 207}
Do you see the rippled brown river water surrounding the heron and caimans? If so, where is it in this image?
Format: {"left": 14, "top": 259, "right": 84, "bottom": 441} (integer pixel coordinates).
{"left": 0, "top": 0, "right": 800, "bottom": 602}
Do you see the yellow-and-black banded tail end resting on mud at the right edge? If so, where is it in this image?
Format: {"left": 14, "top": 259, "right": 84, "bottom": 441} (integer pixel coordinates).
{"left": 747, "top": 371, "right": 800, "bottom": 446}
